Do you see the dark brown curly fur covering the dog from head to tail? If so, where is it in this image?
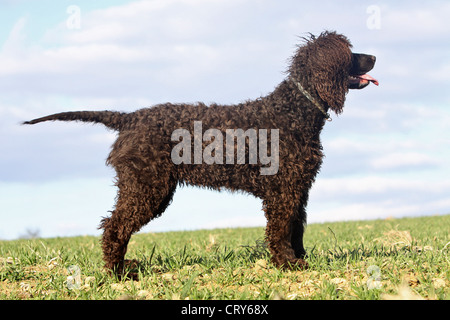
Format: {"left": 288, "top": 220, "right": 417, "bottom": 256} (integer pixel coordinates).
{"left": 26, "top": 32, "right": 374, "bottom": 274}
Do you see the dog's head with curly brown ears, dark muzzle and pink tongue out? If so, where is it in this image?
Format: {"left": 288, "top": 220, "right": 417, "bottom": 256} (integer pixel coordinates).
{"left": 289, "top": 31, "right": 378, "bottom": 113}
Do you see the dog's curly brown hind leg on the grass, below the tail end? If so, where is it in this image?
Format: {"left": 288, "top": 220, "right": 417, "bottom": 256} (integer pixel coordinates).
{"left": 100, "top": 168, "right": 176, "bottom": 277}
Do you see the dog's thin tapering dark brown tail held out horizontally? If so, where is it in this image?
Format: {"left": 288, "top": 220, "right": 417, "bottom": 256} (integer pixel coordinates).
{"left": 22, "top": 111, "right": 128, "bottom": 131}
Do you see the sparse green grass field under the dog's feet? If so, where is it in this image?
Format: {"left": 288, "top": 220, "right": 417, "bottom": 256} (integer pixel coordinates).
{"left": 0, "top": 215, "right": 450, "bottom": 300}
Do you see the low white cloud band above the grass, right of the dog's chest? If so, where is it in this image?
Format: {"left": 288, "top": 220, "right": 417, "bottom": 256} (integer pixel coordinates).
{"left": 308, "top": 176, "right": 450, "bottom": 222}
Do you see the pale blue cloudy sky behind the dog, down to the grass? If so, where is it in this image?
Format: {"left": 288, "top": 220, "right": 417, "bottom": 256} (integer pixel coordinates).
{"left": 0, "top": 0, "right": 450, "bottom": 239}
